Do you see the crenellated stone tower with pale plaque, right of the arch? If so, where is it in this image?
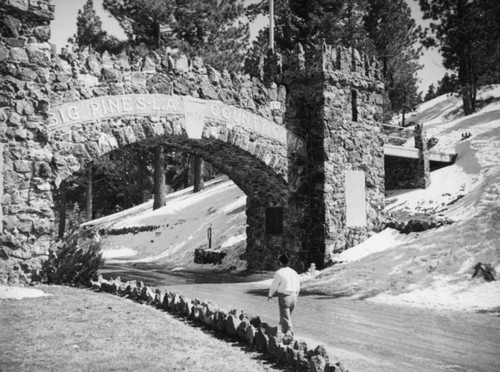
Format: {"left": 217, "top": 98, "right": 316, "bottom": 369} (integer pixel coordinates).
{"left": 283, "top": 45, "right": 385, "bottom": 268}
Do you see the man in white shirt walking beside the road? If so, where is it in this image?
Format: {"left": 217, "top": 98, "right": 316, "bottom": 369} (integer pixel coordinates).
{"left": 267, "top": 253, "right": 300, "bottom": 336}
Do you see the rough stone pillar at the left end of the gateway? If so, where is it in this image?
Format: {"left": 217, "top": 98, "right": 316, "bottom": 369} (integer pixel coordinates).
{"left": 0, "top": 0, "right": 54, "bottom": 283}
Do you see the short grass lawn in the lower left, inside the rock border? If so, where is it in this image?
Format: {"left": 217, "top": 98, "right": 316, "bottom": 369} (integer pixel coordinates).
{"left": 0, "top": 286, "right": 279, "bottom": 372}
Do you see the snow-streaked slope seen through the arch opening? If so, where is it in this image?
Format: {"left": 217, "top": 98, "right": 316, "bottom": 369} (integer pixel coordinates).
{"left": 86, "top": 177, "right": 250, "bottom": 270}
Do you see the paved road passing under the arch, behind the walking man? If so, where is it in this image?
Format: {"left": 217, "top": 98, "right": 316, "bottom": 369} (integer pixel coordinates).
{"left": 101, "top": 271, "right": 500, "bottom": 372}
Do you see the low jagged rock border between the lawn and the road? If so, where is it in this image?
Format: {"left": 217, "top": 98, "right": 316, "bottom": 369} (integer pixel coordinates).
{"left": 92, "top": 277, "right": 348, "bottom": 372}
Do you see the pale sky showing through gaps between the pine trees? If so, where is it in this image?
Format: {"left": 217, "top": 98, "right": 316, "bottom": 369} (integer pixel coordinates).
{"left": 51, "top": 0, "right": 446, "bottom": 94}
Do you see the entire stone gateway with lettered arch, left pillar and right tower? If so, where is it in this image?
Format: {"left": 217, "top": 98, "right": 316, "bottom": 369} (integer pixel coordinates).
{"left": 0, "top": 0, "right": 402, "bottom": 280}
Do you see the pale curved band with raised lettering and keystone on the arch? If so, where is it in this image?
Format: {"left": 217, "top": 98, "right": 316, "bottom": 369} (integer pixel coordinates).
{"left": 48, "top": 94, "right": 306, "bottom": 156}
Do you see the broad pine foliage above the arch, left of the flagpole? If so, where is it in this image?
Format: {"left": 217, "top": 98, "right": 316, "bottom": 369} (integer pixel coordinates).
{"left": 103, "top": 0, "right": 249, "bottom": 71}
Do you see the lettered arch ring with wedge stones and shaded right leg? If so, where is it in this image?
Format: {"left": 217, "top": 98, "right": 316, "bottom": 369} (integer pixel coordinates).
{"left": 48, "top": 94, "right": 305, "bottom": 268}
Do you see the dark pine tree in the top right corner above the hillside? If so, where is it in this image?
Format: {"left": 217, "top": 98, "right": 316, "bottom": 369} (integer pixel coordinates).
{"left": 419, "top": 0, "right": 500, "bottom": 115}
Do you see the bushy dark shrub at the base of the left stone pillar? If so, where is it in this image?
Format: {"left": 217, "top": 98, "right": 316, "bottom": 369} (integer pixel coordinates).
{"left": 42, "top": 233, "right": 104, "bottom": 286}
